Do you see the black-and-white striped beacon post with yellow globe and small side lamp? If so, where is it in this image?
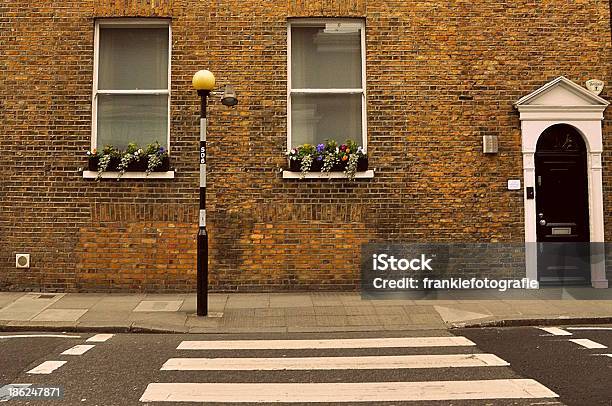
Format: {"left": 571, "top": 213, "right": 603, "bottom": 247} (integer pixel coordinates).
{"left": 192, "top": 70, "right": 238, "bottom": 316}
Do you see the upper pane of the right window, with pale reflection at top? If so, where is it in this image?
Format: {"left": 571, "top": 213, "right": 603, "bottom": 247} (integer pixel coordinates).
{"left": 291, "top": 23, "right": 361, "bottom": 89}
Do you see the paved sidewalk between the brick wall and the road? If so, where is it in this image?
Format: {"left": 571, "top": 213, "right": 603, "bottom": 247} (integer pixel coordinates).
{"left": 0, "top": 288, "right": 612, "bottom": 333}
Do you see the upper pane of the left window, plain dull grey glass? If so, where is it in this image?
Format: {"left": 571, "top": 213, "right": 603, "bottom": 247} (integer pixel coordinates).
{"left": 98, "top": 27, "right": 168, "bottom": 90}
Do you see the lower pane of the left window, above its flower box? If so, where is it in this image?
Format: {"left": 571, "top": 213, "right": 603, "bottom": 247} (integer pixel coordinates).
{"left": 97, "top": 95, "right": 168, "bottom": 148}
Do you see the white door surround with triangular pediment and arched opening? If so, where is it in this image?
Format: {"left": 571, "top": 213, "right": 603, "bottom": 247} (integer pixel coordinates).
{"left": 515, "top": 77, "right": 609, "bottom": 288}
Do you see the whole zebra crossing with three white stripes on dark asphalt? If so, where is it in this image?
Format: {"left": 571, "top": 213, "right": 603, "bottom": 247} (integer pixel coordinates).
{"left": 140, "top": 336, "right": 558, "bottom": 404}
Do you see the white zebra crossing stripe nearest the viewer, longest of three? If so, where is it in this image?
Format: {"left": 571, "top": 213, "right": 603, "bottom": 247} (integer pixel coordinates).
{"left": 140, "top": 379, "right": 558, "bottom": 403}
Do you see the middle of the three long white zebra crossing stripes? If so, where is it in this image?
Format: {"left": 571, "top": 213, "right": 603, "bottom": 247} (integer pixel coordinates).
{"left": 161, "top": 354, "right": 510, "bottom": 371}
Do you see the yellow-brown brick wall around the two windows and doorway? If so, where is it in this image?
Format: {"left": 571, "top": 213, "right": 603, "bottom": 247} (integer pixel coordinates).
{"left": 0, "top": 0, "right": 612, "bottom": 291}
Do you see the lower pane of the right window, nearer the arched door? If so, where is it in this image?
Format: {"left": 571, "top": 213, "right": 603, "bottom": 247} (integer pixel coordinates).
{"left": 291, "top": 94, "right": 363, "bottom": 147}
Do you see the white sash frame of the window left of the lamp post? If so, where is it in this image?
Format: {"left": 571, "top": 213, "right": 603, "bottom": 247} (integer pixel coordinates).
{"left": 91, "top": 18, "right": 172, "bottom": 153}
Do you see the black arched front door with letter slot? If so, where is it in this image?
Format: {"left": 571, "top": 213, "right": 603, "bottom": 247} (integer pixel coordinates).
{"left": 535, "top": 124, "right": 591, "bottom": 285}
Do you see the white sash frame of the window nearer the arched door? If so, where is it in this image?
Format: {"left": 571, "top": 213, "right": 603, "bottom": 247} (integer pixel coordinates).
{"left": 287, "top": 18, "right": 368, "bottom": 152}
